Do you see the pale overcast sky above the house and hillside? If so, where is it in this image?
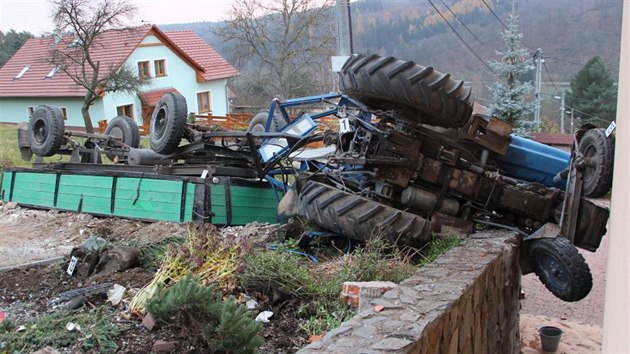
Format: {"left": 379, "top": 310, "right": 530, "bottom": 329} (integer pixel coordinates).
{"left": 0, "top": 0, "right": 237, "bottom": 35}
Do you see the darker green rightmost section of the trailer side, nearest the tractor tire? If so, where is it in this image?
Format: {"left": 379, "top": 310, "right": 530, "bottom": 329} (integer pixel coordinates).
{"left": 211, "top": 185, "right": 282, "bottom": 225}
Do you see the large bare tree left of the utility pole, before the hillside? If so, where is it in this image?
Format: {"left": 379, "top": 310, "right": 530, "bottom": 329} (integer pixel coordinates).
{"left": 216, "top": 0, "right": 335, "bottom": 108}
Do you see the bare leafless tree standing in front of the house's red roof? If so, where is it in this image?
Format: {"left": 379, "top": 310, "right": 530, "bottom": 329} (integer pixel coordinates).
{"left": 47, "top": 0, "right": 149, "bottom": 133}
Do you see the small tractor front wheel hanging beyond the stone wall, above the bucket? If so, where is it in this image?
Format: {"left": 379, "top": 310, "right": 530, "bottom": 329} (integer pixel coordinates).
{"left": 529, "top": 236, "right": 593, "bottom": 302}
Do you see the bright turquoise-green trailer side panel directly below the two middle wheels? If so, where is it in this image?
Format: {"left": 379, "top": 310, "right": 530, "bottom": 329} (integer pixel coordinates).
{"left": 114, "top": 177, "right": 184, "bottom": 222}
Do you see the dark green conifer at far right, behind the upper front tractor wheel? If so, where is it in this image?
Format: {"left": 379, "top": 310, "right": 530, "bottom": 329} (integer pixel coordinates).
{"left": 566, "top": 56, "right": 617, "bottom": 128}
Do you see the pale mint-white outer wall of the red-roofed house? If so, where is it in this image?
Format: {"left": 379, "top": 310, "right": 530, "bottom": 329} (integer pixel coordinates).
{"left": 102, "top": 35, "right": 228, "bottom": 124}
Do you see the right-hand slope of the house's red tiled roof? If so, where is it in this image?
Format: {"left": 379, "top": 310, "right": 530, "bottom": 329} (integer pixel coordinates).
{"left": 165, "top": 31, "right": 238, "bottom": 80}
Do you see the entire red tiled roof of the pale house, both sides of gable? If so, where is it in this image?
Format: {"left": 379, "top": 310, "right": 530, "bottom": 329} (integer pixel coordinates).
{"left": 0, "top": 25, "right": 237, "bottom": 97}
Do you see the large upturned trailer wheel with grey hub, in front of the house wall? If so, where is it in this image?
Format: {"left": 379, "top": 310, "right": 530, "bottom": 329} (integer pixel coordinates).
{"left": 149, "top": 92, "right": 188, "bottom": 155}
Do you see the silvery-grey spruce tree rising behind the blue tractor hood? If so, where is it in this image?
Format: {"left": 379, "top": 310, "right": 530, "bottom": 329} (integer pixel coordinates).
{"left": 488, "top": 15, "right": 534, "bottom": 132}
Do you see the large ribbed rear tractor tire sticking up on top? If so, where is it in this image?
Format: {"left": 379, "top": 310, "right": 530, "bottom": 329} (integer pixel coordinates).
{"left": 339, "top": 54, "right": 473, "bottom": 128}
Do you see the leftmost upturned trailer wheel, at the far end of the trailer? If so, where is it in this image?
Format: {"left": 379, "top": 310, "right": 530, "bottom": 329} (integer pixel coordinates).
{"left": 28, "top": 105, "right": 65, "bottom": 156}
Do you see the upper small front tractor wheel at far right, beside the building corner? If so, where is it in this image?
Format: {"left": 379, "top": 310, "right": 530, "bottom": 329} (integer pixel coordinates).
{"left": 578, "top": 128, "right": 615, "bottom": 198}
